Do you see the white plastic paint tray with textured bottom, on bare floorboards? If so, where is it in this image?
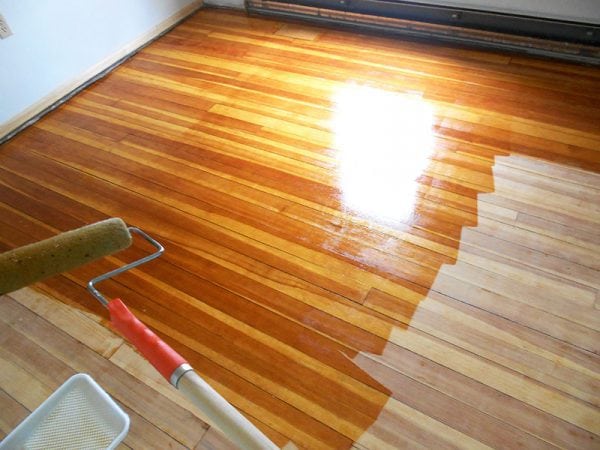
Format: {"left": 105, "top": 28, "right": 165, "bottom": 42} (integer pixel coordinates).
{"left": 0, "top": 374, "right": 129, "bottom": 450}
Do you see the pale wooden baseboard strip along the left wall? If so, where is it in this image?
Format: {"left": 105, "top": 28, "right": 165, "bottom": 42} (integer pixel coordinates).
{"left": 0, "top": 0, "right": 203, "bottom": 144}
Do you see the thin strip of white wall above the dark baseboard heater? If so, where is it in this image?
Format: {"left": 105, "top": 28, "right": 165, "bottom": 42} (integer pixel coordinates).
{"left": 386, "top": 0, "right": 600, "bottom": 24}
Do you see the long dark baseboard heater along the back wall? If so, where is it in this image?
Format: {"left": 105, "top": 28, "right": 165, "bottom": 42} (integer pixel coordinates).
{"left": 246, "top": 0, "right": 600, "bottom": 65}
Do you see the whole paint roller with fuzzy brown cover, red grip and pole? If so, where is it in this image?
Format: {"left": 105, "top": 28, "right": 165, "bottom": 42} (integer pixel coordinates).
{"left": 0, "top": 218, "right": 278, "bottom": 450}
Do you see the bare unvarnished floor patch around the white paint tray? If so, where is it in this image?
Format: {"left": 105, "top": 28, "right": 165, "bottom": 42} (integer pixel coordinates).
{"left": 0, "top": 288, "right": 234, "bottom": 450}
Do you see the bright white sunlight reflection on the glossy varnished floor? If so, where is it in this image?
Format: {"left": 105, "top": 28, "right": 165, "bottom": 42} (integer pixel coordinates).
{"left": 332, "top": 84, "right": 434, "bottom": 221}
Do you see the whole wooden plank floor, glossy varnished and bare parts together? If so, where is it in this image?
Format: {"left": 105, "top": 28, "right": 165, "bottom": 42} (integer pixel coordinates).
{"left": 0, "top": 10, "right": 600, "bottom": 449}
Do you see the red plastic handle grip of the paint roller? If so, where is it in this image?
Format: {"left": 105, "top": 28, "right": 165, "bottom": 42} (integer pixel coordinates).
{"left": 108, "top": 298, "right": 186, "bottom": 382}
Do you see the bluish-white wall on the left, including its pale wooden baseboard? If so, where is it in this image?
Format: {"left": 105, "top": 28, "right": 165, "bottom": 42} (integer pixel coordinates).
{"left": 0, "top": 0, "right": 200, "bottom": 138}
